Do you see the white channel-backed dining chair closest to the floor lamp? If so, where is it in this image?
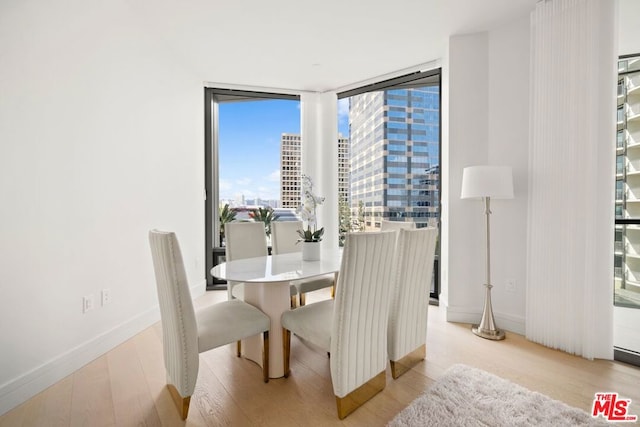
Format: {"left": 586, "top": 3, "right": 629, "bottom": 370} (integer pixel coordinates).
{"left": 387, "top": 228, "right": 438, "bottom": 379}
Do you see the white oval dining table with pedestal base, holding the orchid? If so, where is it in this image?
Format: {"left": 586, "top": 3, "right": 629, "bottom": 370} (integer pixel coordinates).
{"left": 211, "top": 248, "right": 342, "bottom": 378}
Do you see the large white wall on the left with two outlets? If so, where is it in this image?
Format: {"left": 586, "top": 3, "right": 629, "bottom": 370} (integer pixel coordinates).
{"left": 0, "top": 0, "right": 204, "bottom": 414}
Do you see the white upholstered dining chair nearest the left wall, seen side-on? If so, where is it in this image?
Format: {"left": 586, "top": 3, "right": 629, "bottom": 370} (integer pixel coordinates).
{"left": 149, "top": 230, "right": 271, "bottom": 420}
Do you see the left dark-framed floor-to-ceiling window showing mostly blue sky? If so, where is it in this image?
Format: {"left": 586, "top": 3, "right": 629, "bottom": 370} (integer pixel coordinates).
{"left": 205, "top": 88, "right": 300, "bottom": 289}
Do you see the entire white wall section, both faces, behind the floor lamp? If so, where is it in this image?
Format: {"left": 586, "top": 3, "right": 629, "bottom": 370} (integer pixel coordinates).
{"left": 443, "top": 16, "right": 529, "bottom": 333}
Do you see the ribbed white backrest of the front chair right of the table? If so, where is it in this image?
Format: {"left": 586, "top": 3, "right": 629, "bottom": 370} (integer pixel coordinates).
{"left": 330, "top": 231, "right": 396, "bottom": 413}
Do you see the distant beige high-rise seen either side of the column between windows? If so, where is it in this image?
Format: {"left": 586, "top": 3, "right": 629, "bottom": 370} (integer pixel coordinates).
{"left": 280, "top": 133, "right": 349, "bottom": 209}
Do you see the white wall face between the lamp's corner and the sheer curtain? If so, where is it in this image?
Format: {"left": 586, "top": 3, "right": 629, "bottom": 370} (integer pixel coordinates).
{"left": 488, "top": 15, "right": 529, "bottom": 332}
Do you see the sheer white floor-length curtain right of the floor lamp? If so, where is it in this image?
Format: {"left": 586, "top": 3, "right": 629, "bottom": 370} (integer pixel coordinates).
{"left": 526, "top": 0, "right": 617, "bottom": 359}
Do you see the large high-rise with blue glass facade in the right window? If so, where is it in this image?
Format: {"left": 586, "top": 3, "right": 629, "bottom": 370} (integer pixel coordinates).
{"left": 349, "top": 85, "right": 440, "bottom": 229}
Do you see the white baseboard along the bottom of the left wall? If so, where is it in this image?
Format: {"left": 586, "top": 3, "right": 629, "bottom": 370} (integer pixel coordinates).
{"left": 0, "top": 280, "right": 206, "bottom": 415}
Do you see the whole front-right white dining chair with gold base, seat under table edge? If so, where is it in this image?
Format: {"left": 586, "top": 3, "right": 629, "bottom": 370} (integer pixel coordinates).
{"left": 281, "top": 231, "right": 396, "bottom": 419}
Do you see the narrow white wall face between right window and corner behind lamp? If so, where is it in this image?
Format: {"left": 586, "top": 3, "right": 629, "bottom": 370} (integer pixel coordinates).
{"left": 442, "top": 33, "right": 490, "bottom": 320}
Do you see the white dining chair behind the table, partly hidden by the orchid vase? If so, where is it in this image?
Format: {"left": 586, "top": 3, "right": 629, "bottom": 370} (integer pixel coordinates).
{"left": 271, "top": 221, "right": 335, "bottom": 306}
